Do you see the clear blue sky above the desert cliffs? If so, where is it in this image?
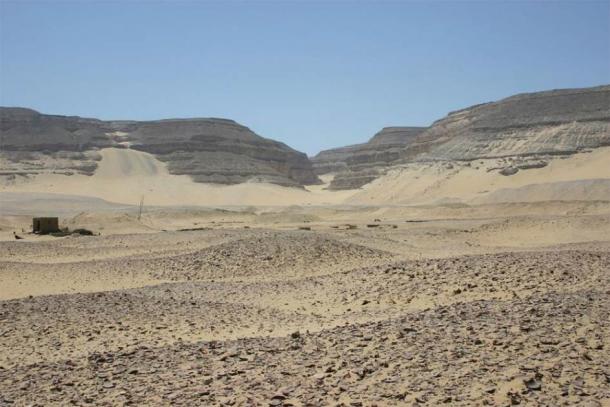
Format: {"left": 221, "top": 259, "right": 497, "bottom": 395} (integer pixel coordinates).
{"left": 0, "top": 0, "right": 610, "bottom": 154}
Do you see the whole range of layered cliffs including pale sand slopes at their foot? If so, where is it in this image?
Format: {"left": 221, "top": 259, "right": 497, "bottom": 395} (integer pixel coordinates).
{"left": 0, "top": 86, "right": 610, "bottom": 206}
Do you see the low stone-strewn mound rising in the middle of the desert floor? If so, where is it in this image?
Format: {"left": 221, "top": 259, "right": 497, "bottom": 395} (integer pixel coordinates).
{"left": 150, "top": 231, "right": 392, "bottom": 280}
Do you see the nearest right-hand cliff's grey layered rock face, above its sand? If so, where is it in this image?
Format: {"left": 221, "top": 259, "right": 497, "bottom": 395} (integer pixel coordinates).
{"left": 419, "top": 86, "right": 610, "bottom": 160}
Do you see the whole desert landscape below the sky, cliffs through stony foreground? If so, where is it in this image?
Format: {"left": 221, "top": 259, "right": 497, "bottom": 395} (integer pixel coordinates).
{"left": 0, "top": 85, "right": 610, "bottom": 406}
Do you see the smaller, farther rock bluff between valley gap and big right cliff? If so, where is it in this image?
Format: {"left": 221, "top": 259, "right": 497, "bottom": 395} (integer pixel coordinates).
{"left": 311, "top": 127, "right": 426, "bottom": 189}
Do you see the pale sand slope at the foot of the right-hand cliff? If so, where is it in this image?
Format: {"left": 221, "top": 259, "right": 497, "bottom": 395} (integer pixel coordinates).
{"left": 350, "top": 147, "right": 610, "bottom": 205}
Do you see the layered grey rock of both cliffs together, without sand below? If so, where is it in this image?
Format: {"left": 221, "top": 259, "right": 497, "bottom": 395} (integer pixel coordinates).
{"left": 0, "top": 86, "right": 610, "bottom": 189}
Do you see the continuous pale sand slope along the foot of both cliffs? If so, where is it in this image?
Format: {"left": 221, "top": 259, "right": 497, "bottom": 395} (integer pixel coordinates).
{"left": 0, "top": 147, "right": 610, "bottom": 209}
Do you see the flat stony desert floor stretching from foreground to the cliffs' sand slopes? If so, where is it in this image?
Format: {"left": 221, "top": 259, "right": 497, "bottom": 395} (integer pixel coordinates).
{"left": 0, "top": 202, "right": 610, "bottom": 406}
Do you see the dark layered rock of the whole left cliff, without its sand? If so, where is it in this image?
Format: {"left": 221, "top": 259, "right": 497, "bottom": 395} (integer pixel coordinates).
{"left": 0, "top": 108, "right": 319, "bottom": 186}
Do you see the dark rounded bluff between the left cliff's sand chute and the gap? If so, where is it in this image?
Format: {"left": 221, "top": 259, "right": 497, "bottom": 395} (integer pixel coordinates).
{"left": 128, "top": 119, "right": 319, "bottom": 186}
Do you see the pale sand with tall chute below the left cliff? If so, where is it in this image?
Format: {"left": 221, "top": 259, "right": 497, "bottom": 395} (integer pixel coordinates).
{"left": 0, "top": 148, "right": 353, "bottom": 206}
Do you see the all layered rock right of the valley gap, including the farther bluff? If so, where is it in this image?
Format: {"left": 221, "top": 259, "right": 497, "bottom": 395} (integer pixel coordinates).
{"left": 313, "top": 86, "right": 610, "bottom": 189}
